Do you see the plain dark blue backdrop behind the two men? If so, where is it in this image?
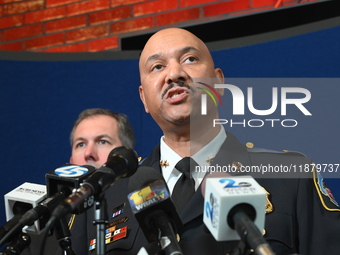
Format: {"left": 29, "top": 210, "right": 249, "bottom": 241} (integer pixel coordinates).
{"left": 0, "top": 27, "right": 340, "bottom": 225}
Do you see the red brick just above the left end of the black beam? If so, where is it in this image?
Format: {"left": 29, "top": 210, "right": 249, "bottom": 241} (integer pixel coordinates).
{"left": 110, "top": 16, "right": 154, "bottom": 34}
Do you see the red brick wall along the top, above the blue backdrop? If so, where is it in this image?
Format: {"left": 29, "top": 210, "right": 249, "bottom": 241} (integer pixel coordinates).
{"left": 0, "top": 0, "right": 315, "bottom": 52}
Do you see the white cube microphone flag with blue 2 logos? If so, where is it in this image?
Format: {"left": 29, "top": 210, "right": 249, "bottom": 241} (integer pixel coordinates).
{"left": 203, "top": 176, "right": 266, "bottom": 241}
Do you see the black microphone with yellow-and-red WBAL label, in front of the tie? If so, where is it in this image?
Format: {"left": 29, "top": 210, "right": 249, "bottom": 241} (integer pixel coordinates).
{"left": 128, "top": 167, "right": 183, "bottom": 255}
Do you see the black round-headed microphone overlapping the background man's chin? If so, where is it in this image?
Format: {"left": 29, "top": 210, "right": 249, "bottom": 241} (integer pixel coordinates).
{"left": 50, "top": 146, "right": 138, "bottom": 221}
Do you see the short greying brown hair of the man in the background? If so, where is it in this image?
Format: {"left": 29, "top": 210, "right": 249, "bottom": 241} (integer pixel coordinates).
{"left": 70, "top": 108, "right": 135, "bottom": 149}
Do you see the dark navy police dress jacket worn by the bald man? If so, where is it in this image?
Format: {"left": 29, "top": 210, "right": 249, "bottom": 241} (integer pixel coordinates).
{"left": 59, "top": 132, "right": 340, "bottom": 255}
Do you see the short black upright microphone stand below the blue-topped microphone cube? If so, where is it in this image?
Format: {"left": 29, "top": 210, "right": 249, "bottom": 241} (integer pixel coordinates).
{"left": 55, "top": 217, "right": 76, "bottom": 255}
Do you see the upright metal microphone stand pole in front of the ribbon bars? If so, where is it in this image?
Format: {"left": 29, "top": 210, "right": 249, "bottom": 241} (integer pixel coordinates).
{"left": 93, "top": 194, "right": 109, "bottom": 255}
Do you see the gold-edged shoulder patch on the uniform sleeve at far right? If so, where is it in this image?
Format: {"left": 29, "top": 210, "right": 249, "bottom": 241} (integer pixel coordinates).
{"left": 313, "top": 171, "right": 340, "bottom": 211}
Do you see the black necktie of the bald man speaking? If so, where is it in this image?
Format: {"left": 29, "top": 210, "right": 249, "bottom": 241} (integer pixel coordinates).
{"left": 171, "top": 157, "right": 197, "bottom": 212}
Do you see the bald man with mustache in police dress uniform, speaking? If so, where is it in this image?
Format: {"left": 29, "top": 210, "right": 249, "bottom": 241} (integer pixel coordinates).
{"left": 135, "top": 28, "right": 340, "bottom": 255}
